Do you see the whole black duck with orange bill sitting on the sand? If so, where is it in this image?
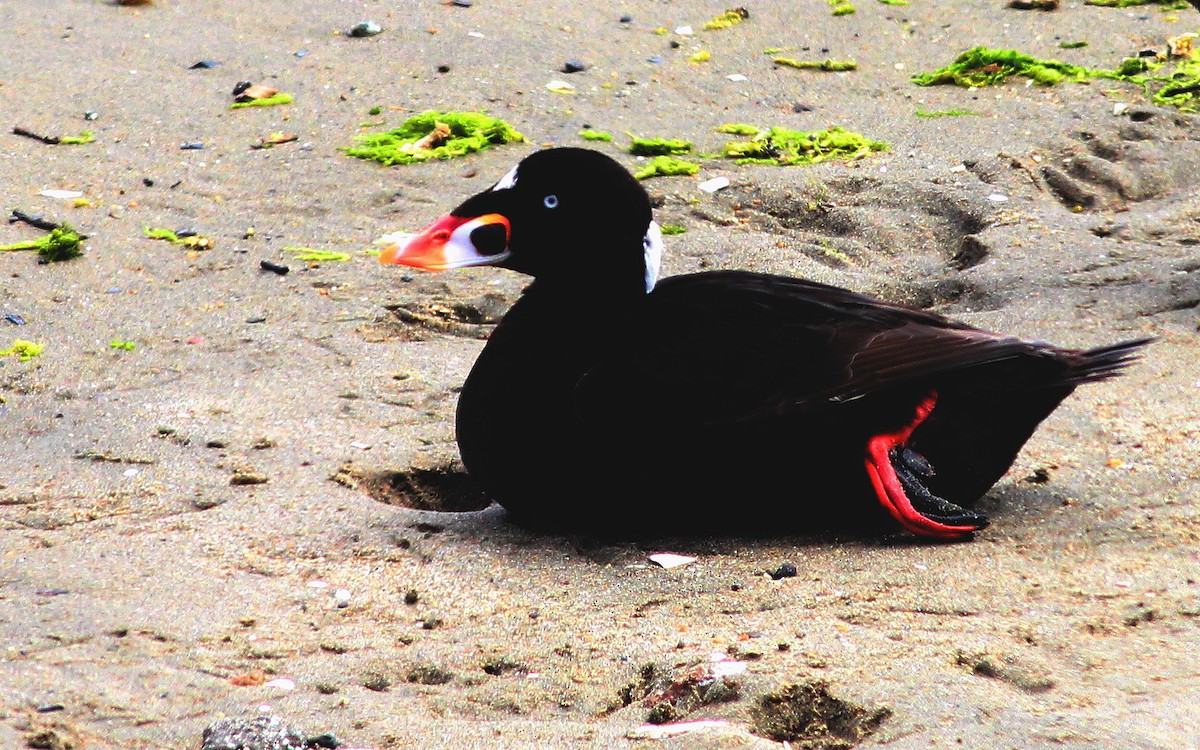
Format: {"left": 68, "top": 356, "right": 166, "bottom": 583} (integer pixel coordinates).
{"left": 379, "top": 148, "right": 1151, "bottom": 541}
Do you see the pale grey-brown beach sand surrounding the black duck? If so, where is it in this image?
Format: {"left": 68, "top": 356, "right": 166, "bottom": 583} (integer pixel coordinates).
{"left": 0, "top": 0, "right": 1200, "bottom": 750}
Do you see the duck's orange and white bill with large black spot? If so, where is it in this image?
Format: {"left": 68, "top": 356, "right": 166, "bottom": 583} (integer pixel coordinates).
{"left": 379, "top": 214, "right": 511, "bottom": 271}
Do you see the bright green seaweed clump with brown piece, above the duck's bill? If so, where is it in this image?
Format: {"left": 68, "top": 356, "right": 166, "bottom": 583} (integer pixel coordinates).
{"left": 342, "top": 112, "right": 526, "bottom": 167}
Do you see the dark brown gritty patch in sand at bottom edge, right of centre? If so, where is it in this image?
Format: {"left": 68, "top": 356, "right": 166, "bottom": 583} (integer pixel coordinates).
{"left": 750, "top": 680, "right": 892, "bottom": 750}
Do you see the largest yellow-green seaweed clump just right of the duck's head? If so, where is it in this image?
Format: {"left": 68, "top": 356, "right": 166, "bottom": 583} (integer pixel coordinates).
{"left": 721, "top": 125, "right": 888, "bottom": 167}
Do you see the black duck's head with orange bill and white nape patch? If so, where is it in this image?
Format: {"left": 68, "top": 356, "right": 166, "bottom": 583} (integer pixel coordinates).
{"left": 379, "top": 149, "right": 662, "bottom": 293}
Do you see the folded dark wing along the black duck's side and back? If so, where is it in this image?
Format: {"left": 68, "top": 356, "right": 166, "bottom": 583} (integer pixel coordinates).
{"left": 575, "top": 271, "right": 1070, "bottom": 426}
